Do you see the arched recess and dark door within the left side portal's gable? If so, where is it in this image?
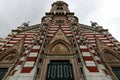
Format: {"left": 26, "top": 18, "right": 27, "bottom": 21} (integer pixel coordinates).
{"left": 0, "top": 50, "right": 18, "bottom": 80}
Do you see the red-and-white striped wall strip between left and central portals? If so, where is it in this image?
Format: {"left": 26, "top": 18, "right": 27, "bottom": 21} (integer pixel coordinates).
{"left": 9, "top": 26, "right": 44, "bottom": 80}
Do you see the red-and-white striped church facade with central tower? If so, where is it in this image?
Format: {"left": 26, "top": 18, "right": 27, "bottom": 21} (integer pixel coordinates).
{"left": 0, "top": 1, "right": 120, "bottom": 80}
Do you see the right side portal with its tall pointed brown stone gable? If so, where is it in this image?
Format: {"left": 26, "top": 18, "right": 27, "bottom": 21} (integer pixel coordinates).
{"left": 96, "top": 38, "right": 120, "bottom": 80}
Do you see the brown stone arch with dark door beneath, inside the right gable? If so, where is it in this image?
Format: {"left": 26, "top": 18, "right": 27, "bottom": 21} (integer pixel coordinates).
{"left": 102, "top": 49, "right": 120, "bottom": 80}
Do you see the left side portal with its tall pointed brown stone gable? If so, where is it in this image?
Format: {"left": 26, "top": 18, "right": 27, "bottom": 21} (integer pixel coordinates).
{"left": 0, "top": 39, "right": 24, "bottom": 80}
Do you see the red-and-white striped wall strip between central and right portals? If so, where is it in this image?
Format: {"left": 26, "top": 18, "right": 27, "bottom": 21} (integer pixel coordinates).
{"left": 76, "top": 27, "right": 112, "bottom": 80}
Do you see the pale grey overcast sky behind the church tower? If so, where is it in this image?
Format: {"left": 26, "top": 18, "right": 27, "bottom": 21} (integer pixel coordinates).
{"left": 0, "top": 0, "right": 120, "bottom": 41}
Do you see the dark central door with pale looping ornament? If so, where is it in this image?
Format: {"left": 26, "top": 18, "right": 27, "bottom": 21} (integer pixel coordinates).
{"left": 46, "top": 60, "right": 74, "bottom": 80}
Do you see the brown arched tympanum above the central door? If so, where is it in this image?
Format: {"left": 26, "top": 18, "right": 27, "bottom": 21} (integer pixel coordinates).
{"left": 45, "top": 39, "right": 75, "bottom": 54}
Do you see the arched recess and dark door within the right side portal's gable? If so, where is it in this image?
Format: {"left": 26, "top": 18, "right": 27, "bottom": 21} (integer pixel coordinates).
{"left": 104, "top": 51, "right": 120, "bottom": 80}
